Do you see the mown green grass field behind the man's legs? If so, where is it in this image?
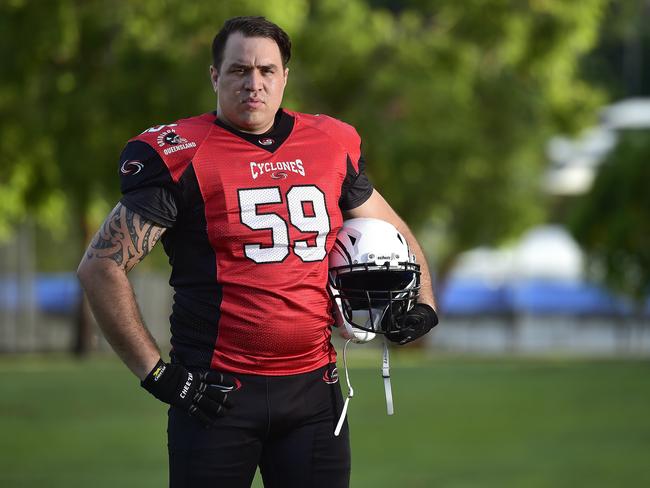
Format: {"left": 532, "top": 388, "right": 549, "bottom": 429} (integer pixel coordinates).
{"left": 0, "top": 351, "right": 650, "bottom": 488}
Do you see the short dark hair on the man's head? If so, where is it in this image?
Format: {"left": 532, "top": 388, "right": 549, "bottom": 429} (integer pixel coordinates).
{"left": 212, "top": 17, "right": 291, "bottom": 70}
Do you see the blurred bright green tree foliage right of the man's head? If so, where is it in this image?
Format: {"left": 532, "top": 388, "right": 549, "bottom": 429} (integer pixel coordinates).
{"left": 291, "top": 0, "right": 604, "bottom": 275}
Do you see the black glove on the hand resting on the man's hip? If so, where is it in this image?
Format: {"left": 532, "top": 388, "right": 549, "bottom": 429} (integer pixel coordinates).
{"left": 140, "top": 359, "right": 240, "bottom": 426}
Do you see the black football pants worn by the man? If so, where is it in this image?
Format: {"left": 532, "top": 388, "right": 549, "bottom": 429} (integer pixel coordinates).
{"left": 167, "top": 365, "right": 350, "bottom": 488}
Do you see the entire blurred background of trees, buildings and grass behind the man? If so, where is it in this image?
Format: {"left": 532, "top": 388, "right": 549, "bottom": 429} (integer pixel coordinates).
{"left": 0, "top": 0, "right": 650, "bottom": 487}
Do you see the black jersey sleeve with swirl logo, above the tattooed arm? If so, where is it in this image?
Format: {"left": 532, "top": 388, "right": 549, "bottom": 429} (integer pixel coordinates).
{"left": 119, "top": 141, "right": 180, "bottom": 227}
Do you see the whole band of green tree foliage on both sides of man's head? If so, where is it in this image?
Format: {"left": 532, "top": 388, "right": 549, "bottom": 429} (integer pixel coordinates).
{"left": 0, "top": 0, "right": 604, "bottom": 350}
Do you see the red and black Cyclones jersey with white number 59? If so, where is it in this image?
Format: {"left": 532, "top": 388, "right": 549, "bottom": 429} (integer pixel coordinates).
{"left": 120, "top": 110, "right": 372, "bottom": 375}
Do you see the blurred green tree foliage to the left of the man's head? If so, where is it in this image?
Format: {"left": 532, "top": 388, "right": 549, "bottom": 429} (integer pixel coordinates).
{"left": 0, "top": 0, "right": 304, "bottom": 354}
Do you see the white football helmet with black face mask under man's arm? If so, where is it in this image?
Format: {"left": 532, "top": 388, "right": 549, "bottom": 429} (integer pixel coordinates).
{"left": 329, "top": 218, "right": 420, "bottom": 342}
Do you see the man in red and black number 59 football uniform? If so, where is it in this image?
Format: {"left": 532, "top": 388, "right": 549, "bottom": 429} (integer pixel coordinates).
{"left": 78, "top": 17, "right": 436, "bottom": 488}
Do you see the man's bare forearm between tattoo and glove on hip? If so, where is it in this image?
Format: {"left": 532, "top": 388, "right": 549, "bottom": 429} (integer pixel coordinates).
{"left": 77, "top": 260, "right": 160, "bottom": 380}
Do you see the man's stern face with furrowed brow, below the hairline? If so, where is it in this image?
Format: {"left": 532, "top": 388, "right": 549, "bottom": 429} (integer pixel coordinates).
{"left": 210, "top": 32, "right": 289, "bottom": 134}
